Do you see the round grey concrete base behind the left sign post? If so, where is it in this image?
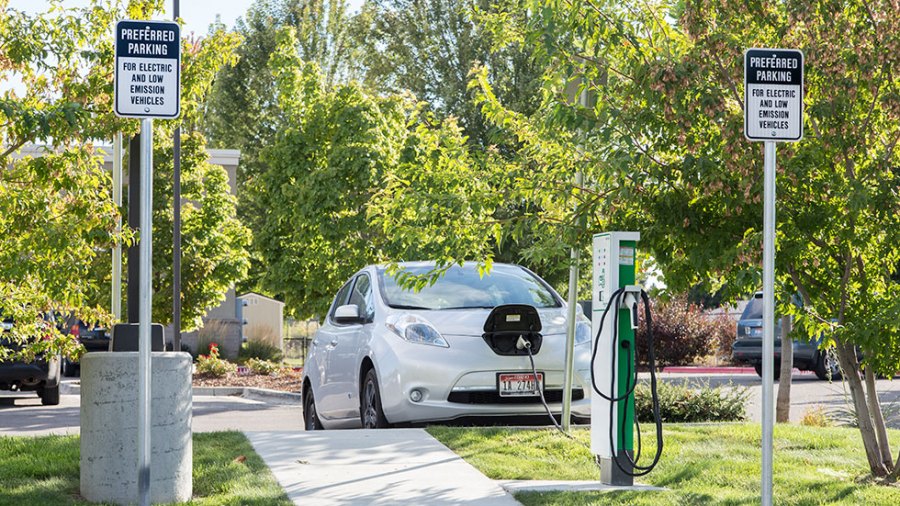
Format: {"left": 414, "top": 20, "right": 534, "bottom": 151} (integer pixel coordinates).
{"left": 81, "top": 352, "right": 193, "bottom": 504}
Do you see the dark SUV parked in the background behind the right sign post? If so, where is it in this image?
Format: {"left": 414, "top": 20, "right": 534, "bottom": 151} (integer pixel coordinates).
{"left": 731, "top": 292, "right": 841, "bottom": 380}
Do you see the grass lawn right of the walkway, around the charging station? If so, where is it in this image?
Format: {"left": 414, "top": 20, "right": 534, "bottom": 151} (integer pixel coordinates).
{"left": 428, "top": 423, "right": 900, "bottom": 506}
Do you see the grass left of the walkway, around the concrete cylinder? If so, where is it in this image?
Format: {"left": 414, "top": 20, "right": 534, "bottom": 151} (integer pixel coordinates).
{"left": 0, "top": 432, "right": 293, "bottom": 506}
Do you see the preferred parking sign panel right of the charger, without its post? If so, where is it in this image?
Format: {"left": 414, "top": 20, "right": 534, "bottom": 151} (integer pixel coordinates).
{"left": 744, "top": 49, "right": 803, "bottom": 142}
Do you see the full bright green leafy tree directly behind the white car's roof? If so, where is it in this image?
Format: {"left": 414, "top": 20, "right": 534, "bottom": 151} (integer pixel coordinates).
{"left": 257, "top": 25, "right": 493, "bottom": 316}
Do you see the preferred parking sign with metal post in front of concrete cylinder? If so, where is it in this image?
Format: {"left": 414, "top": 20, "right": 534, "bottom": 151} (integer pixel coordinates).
{"left": 114, "top": 20, "right": 181, "bottom": 506}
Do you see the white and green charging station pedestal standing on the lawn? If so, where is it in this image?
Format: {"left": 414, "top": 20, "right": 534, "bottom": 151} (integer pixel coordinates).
{"left": 591, "top": 232, "right": 641, "bottom": 486}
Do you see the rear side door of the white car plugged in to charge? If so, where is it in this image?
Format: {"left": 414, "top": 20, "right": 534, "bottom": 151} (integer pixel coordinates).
{"left": 307, "top": 279, "right": 354, "bottom": 419}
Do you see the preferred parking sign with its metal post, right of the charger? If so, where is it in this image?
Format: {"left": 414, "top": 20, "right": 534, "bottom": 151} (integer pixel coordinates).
{"left": 744, "top": 49, "right": 803, "bottom": 506}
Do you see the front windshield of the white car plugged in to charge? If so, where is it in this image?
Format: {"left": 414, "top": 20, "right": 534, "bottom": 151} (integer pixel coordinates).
{"left": 378, "top": 265, "right": 560, "bottom": 310}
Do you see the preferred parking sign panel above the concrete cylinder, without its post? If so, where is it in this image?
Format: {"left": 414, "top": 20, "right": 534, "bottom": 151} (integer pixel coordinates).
{"left": 115, "top": 20, "right": 181, "bottom": 118}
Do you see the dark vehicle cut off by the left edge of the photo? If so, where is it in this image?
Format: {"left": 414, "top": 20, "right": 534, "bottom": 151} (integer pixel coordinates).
{"left": 0, "top": 315, "right": 60, "bottom": 406}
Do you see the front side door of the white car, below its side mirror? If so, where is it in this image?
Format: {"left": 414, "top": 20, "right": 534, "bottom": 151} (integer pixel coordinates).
{"left": 328, "top": 273, "right": 374, "bottom": 418}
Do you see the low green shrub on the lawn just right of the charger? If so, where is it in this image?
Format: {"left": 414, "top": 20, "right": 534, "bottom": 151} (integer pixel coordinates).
{"left": 634, "top": 381, "right": 750, "bottom": 423}
